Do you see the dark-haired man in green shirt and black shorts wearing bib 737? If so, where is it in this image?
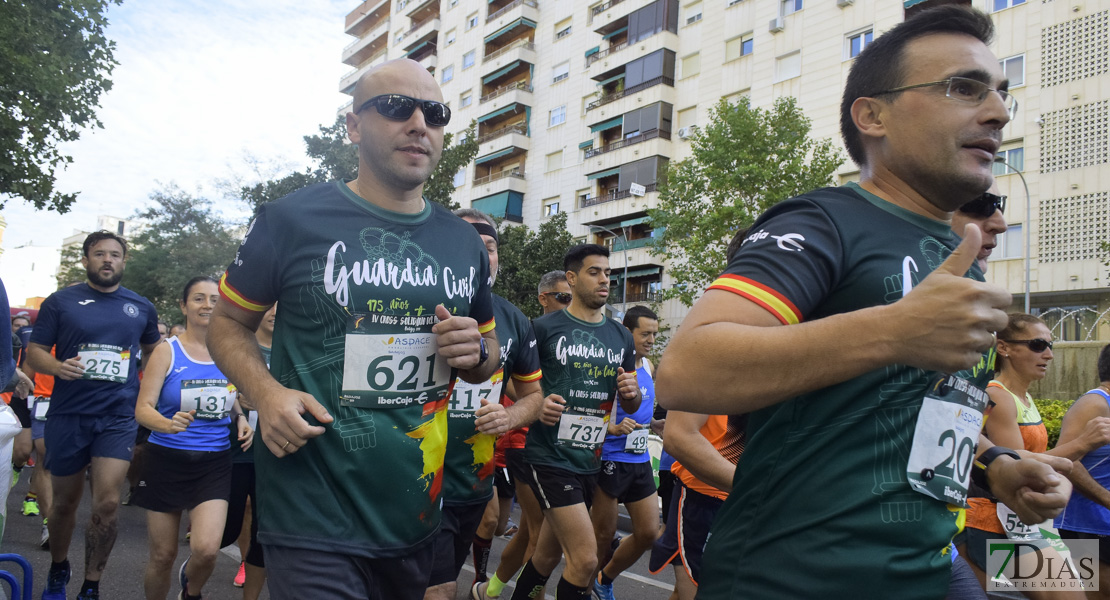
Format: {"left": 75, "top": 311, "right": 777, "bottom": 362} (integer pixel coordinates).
{"left": 513, "top": 244, "right": 642, "bottom": 600}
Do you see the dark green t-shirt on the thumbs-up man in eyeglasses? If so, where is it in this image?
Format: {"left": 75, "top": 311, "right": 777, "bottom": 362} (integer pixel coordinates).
{"left": 698, "top": 185, "right": 989, "bottom": 600}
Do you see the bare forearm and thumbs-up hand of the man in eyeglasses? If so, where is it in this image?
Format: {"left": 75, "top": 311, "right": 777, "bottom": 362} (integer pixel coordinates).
{"left": 656, "top": 225, "right": 1010, "bottom": 414}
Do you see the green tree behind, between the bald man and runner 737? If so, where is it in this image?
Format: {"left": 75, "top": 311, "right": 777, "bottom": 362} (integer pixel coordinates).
{"left": 493, "top": 213, "right": 574, "bottom": 318}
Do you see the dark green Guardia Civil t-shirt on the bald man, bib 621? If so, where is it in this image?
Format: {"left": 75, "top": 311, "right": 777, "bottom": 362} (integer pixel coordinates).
{"left": 220, "top": 182, "right": 494, "bottom": 558}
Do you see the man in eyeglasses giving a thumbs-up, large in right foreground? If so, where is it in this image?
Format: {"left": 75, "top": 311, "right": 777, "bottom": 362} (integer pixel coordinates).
{"left": 656, "top": 6, "right": 1071, "bottom": 600}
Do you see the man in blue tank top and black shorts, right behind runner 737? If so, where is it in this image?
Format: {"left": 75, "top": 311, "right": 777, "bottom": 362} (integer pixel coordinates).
{"left": 589, "top": 306, "right": 659, "bottom": 600}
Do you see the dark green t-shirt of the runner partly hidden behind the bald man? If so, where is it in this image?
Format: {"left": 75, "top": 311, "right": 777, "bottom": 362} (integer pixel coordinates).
{"left": 443, "top": 294, "right": 541, "bottom": 505}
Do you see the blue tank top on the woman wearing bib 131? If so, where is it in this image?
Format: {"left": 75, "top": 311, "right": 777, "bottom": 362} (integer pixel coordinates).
{"left": 150, "top": 337, "right": 235, "bottom": 451}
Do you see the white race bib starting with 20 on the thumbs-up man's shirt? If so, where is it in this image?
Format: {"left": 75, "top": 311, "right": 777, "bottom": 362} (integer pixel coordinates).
{"left": 906, "top": 375, "right": 988, "bottom": 507}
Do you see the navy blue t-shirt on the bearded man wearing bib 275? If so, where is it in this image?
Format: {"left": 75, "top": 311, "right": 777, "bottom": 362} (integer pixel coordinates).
{"left": 31, "top": 284, "right": 161, "bottom": 417}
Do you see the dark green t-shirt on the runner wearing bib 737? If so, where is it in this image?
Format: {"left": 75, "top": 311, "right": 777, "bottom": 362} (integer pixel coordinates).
{"left": 524, "top": 309, "right": 636, "bottom": 474}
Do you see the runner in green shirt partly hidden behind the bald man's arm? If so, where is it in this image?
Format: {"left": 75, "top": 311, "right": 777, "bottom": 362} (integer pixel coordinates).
{"left": 424, "top": 209, "right": 548, "bottom": 600}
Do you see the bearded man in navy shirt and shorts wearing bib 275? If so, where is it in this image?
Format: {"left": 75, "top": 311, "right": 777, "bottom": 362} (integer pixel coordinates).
{"left": 28, "top": 231, "right": 161, "bottom": 600}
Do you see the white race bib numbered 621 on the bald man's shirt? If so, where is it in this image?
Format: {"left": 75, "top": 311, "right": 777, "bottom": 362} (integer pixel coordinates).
{"left": 340, "top": 314, "right": 446, "bottom": 408}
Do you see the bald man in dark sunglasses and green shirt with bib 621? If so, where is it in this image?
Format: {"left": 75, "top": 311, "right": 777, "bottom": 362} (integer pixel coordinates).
{"left": 209, "top": 59, "right": 500, "bottom": 600}
